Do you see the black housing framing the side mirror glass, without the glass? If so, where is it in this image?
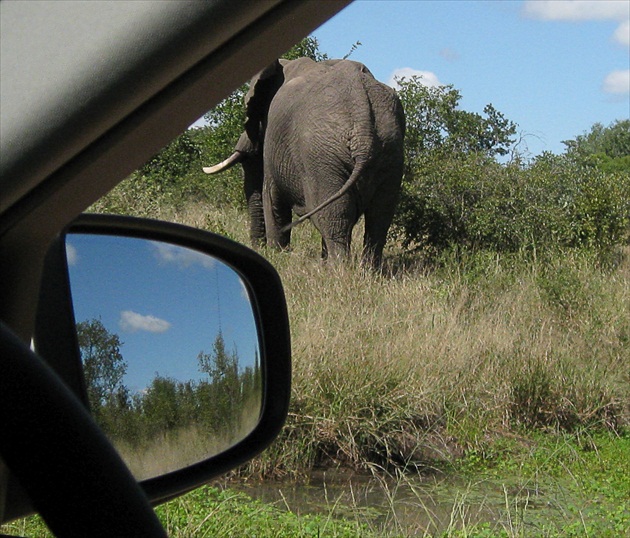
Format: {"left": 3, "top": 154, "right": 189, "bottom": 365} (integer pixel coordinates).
{"left": 34, "top": 214, "right": 291, "bottom": 504}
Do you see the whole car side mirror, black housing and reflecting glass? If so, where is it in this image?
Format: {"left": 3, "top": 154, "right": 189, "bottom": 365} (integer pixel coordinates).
{"left": 34, "top": 215, "right": 291, "bottom": 503}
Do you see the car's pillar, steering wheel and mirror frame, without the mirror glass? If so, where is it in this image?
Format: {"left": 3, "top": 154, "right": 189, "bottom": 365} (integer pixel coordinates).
{"left": 0, "top": 0, "right": 350, "bottom": 537}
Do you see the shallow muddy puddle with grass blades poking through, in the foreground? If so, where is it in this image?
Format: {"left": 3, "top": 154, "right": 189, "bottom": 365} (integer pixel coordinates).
{"left": 233, "top": 466, "right": 604, "bottom": 536}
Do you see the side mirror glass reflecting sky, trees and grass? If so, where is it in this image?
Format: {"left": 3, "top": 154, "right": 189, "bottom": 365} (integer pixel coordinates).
{"left": 66, "top": 234, "right": 262, "bottom": 480}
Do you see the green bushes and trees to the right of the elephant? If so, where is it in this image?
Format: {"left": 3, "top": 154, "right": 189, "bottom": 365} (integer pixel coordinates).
{"left": 393, "top": 77, "right": 630, "bottom": 252}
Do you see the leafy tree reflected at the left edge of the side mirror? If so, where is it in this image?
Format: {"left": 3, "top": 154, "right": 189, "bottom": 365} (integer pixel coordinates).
{"left": 77, "top": 319, "right": 127, "bottom": 413}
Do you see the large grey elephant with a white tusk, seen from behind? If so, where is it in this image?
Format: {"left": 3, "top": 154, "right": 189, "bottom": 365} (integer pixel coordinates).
{"left": 204, "top": 58, "right": 405, "bottom": 267}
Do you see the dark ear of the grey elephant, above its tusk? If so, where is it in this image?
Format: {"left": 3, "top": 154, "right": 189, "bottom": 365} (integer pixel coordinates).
{"left": 245, "top": 60, "right": 284, "bottom": 145}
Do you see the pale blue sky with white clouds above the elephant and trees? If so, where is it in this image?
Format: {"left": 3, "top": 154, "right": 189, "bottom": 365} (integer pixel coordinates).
{"left": 313, "top": 0, "right": 630, "bottom": 156}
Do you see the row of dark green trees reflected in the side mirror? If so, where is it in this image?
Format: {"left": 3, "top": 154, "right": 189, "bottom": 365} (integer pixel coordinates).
{"left": 77, "top": 320, "right": 262, "bottom": 447}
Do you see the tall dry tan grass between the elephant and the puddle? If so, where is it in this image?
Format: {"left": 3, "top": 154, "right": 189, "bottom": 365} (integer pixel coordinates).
{"left": 91, "top": 199, "right": 630, "bottom": 475}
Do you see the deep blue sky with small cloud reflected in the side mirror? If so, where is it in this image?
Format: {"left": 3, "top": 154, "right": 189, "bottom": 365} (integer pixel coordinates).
{"left": 66, "top": 234, "right": 258, "bottom": 393}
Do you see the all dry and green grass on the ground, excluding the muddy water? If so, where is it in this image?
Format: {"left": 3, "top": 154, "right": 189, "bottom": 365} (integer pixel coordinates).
{"left": 5, "top": 193, "right": 630, "bottom": 537}
